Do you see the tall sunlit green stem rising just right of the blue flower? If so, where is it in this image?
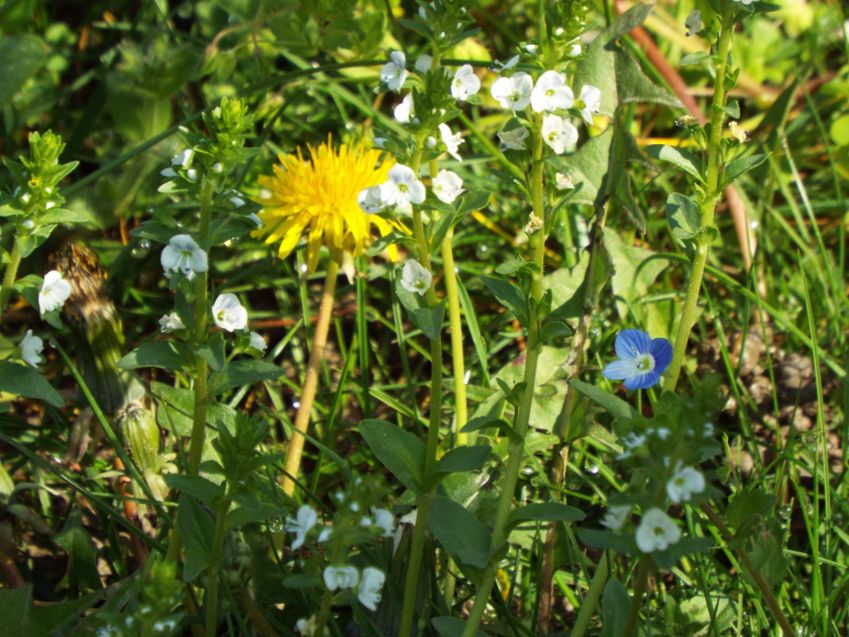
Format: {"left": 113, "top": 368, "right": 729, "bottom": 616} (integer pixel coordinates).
{"left": 664, "top": 14, "right": 734, "bottom": 391}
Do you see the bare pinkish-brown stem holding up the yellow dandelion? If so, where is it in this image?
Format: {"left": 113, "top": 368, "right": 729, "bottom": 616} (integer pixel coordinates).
{"left": 283, "top": 259, "right": 339, "bottom": 495}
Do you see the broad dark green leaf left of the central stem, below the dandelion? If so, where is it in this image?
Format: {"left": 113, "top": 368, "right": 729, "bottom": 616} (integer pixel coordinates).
{"left": 359, "top": 419, "right": 425, "bottom": 493}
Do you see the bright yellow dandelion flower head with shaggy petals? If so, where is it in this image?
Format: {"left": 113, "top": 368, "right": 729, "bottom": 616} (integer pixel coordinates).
{"left": 254, "top": 138, "right": 393, "bottom": 272}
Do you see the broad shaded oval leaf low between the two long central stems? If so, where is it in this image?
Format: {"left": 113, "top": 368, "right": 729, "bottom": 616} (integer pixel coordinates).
{"left": 428, "top": 495, "right": 490, "bottom": 568}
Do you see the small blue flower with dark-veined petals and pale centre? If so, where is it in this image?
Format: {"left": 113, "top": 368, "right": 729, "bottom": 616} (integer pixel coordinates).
{"left": 602, "top": 330, "right": 672, "bottom": 389}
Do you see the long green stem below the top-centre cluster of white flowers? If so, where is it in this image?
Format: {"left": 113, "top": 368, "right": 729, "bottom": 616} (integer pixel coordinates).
{"left": 463, "top": 116, "right": 545, "bottom": 637}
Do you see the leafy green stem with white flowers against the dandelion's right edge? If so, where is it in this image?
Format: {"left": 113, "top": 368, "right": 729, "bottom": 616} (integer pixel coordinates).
{"left": 398, "top": 137, "right": 442, "bottom": 637}
